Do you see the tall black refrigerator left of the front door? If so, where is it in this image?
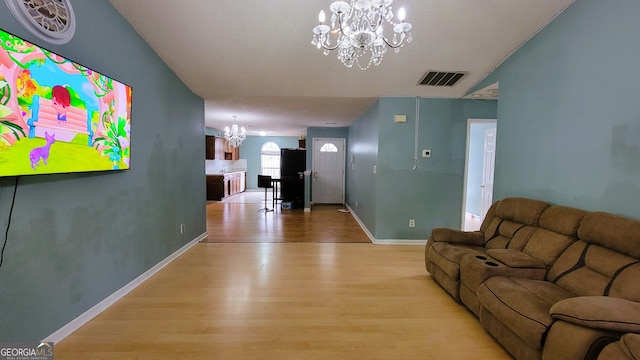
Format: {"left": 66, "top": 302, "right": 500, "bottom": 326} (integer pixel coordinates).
{"left": 280, "top": 149, "right": 307, "bottom": 209}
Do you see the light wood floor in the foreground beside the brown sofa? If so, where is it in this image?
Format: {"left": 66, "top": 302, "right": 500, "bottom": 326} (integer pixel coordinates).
{"left": 55, "top": 198, "right": 509, "bottom": 360}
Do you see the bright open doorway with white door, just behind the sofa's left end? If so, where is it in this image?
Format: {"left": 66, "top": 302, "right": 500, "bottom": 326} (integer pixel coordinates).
{"left": 462, "top": 119, "right": 497, "bottom": 231}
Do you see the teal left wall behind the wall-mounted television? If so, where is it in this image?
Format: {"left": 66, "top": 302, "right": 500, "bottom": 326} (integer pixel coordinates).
{"left": 0, "top": 0, "right": 206, "bottom": 342}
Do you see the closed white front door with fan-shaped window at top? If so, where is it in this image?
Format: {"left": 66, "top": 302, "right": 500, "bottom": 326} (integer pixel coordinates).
{"left": 311, "top": 138, "right": 345, "bottom": 204}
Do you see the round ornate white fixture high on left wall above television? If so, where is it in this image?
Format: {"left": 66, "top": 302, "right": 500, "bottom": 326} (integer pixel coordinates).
{"left": 4, "top": 0, "right": 76, "bottom": 45}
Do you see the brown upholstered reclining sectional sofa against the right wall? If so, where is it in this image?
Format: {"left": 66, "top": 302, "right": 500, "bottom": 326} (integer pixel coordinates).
{"left": 425, "top": 198, "right": 640, "bottom": 359}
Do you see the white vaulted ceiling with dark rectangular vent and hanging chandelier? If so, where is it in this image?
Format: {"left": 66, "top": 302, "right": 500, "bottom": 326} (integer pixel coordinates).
{"left": 110, "top": 0, "right": 574, "bottom": 136}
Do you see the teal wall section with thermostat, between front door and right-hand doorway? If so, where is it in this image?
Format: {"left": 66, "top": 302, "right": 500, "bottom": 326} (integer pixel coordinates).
{"left": 347, "top": 97, "right": 496, "bottom": 240}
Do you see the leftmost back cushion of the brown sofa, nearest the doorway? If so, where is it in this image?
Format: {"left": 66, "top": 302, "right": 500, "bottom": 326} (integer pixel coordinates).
{"left": 484, "top": 198, "right": 549, "bottom": 250}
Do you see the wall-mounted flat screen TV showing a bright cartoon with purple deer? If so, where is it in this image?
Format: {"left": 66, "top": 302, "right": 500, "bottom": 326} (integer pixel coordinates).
{"left": 0, "top": 30, "right": 131, "bottom": 177}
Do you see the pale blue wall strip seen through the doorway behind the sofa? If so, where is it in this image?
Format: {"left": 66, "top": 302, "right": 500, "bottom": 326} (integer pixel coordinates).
{"left": 466, "top": 123, "right": 496, "bottom": 216}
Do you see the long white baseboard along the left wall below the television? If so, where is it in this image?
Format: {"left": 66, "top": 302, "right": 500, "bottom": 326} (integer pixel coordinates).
{"left": 42, "top": 232, "right": 207, "bottom": 344}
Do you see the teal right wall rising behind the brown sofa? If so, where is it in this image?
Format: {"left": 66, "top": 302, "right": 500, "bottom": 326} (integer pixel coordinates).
{"left": 486, "top": 0, "right": 640, "bottom": 218}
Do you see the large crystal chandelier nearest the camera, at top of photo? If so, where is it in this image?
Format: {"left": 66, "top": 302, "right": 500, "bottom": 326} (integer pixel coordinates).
{"left": 311, "top": 0, "right": 413, "bottom": 70}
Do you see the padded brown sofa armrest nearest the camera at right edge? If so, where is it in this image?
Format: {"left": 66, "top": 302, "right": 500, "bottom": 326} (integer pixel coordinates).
{"left": 549, "top": 296, "right": 640, "bottom": 333}
